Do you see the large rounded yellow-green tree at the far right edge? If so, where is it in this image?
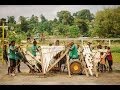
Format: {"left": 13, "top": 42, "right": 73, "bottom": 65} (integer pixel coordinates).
{"left": 94, "top": 7, "right": 120, "bottom": 37}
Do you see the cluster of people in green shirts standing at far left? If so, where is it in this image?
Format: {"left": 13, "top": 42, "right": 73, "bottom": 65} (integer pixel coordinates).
{"left": 3, "top": 40, "right": 21, "bottom": 76}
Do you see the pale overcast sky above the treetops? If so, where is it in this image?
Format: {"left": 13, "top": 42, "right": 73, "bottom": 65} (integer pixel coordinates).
{"left": 0, "top": 5, "right": 120, "bottom": 20}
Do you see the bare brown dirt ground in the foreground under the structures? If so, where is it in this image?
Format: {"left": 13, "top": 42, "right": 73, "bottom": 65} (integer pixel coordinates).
{"left": 0, "top": 63, "right": 120, "bottom": 85}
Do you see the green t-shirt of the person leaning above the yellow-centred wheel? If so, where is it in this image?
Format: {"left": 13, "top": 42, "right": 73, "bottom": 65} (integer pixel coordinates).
{"left": 69, "top": 44, "right": 78, "bottom": 59}
